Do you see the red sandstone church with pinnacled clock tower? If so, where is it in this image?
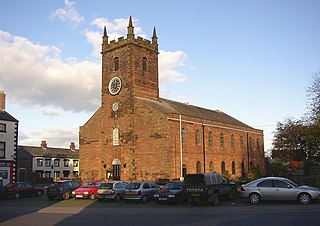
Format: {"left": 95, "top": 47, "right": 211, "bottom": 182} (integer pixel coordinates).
{"left": 79, "top": 17, "right": 265, "bottom": 182}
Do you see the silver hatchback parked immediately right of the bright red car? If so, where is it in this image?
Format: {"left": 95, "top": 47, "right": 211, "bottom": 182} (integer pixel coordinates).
{"left": 97, "top": 181, "right": 128, "bottom": 202}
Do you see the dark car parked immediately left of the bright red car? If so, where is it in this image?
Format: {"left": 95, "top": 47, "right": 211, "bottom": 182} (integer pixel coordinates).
{"left": 47, "top": 180, "right": 80, "bottom": 200}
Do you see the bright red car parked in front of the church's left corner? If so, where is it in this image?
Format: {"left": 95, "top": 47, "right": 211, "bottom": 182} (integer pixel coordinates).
{"left": 72, "top": 181, "right": 101, "bottom": 199}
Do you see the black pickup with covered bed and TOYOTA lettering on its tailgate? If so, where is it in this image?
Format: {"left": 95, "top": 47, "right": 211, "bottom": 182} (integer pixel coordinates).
{"left": 183, "top": 173, "right": 237, "bottom": 205}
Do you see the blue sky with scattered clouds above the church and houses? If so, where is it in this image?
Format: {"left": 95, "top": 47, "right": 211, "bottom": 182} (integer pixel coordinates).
{"left": 0, "top": 0, "right": 320, "bottom": 152}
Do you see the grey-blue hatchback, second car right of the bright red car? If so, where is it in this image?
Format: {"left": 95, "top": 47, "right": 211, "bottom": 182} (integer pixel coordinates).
{"left": 124, "top": 181, "right": 160, "bottom": 203}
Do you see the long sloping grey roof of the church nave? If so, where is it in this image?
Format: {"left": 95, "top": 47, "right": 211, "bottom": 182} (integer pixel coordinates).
{"left": 139, "top": 97, "right": 253, "bottom": 129}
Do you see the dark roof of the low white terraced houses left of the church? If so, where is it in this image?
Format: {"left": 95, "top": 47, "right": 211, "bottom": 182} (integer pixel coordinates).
{"left": 17, "top": 146, "right": 79, "bottom": 159}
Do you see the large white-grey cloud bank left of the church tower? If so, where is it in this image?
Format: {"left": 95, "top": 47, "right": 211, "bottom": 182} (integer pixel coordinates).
{"left": 0, "top": 31, "right": 101, "bottom": 112}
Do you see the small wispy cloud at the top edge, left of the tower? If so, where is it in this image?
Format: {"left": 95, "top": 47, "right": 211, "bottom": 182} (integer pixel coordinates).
{"left": 50, "top": 0, "right": 84, "bottom": 25}
